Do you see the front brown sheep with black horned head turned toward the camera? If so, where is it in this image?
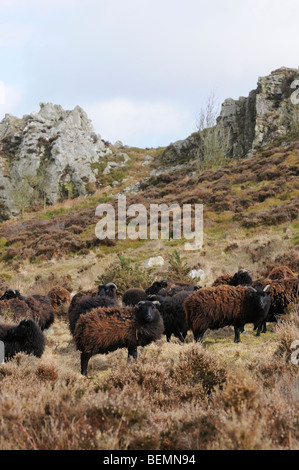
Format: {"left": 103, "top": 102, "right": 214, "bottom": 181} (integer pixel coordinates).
{"left": 74, "top": 301, "right": 164, "bottom": 375}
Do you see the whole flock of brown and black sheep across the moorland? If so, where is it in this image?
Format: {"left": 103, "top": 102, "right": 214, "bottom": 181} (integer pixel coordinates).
{"left": 0, "top": 266, "right": 299, "bottom": 375}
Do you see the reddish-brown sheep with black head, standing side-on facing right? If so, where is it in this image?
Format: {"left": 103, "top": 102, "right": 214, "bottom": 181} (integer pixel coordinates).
{"left": 184, "top": 286, "right": 271, "bottom": 343}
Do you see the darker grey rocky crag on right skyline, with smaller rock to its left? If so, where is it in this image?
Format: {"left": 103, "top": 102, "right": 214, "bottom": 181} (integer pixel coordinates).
{"left": 162, "top": 67, "right": 299, "bottom": 164}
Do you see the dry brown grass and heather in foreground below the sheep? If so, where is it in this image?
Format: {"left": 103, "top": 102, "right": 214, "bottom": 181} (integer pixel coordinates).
{"left": 0, "top": 306, "right": 299, "bottom": 450}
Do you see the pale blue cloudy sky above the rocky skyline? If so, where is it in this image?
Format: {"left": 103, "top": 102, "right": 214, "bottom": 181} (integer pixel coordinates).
{"left": 0, "top": 0, "right": 299, "bottom": 148}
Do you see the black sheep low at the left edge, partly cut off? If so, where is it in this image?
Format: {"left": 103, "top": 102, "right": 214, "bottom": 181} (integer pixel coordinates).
{"left": 0, "top": 319, "right": 45, "bottom": 359}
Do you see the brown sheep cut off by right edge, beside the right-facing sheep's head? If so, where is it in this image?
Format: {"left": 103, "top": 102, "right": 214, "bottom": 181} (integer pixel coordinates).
{"left": 252, "top": 277, "right": 299, "bottom": 336}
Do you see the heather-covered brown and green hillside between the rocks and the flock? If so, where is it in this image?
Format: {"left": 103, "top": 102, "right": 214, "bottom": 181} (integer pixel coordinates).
{"left": 0, "top": 138, "right": 299, "bottom": 289}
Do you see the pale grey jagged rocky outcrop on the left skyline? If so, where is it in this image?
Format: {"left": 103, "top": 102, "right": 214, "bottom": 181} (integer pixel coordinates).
{"left": 0, "top": 103, "right": 112, "bottom": 217}
